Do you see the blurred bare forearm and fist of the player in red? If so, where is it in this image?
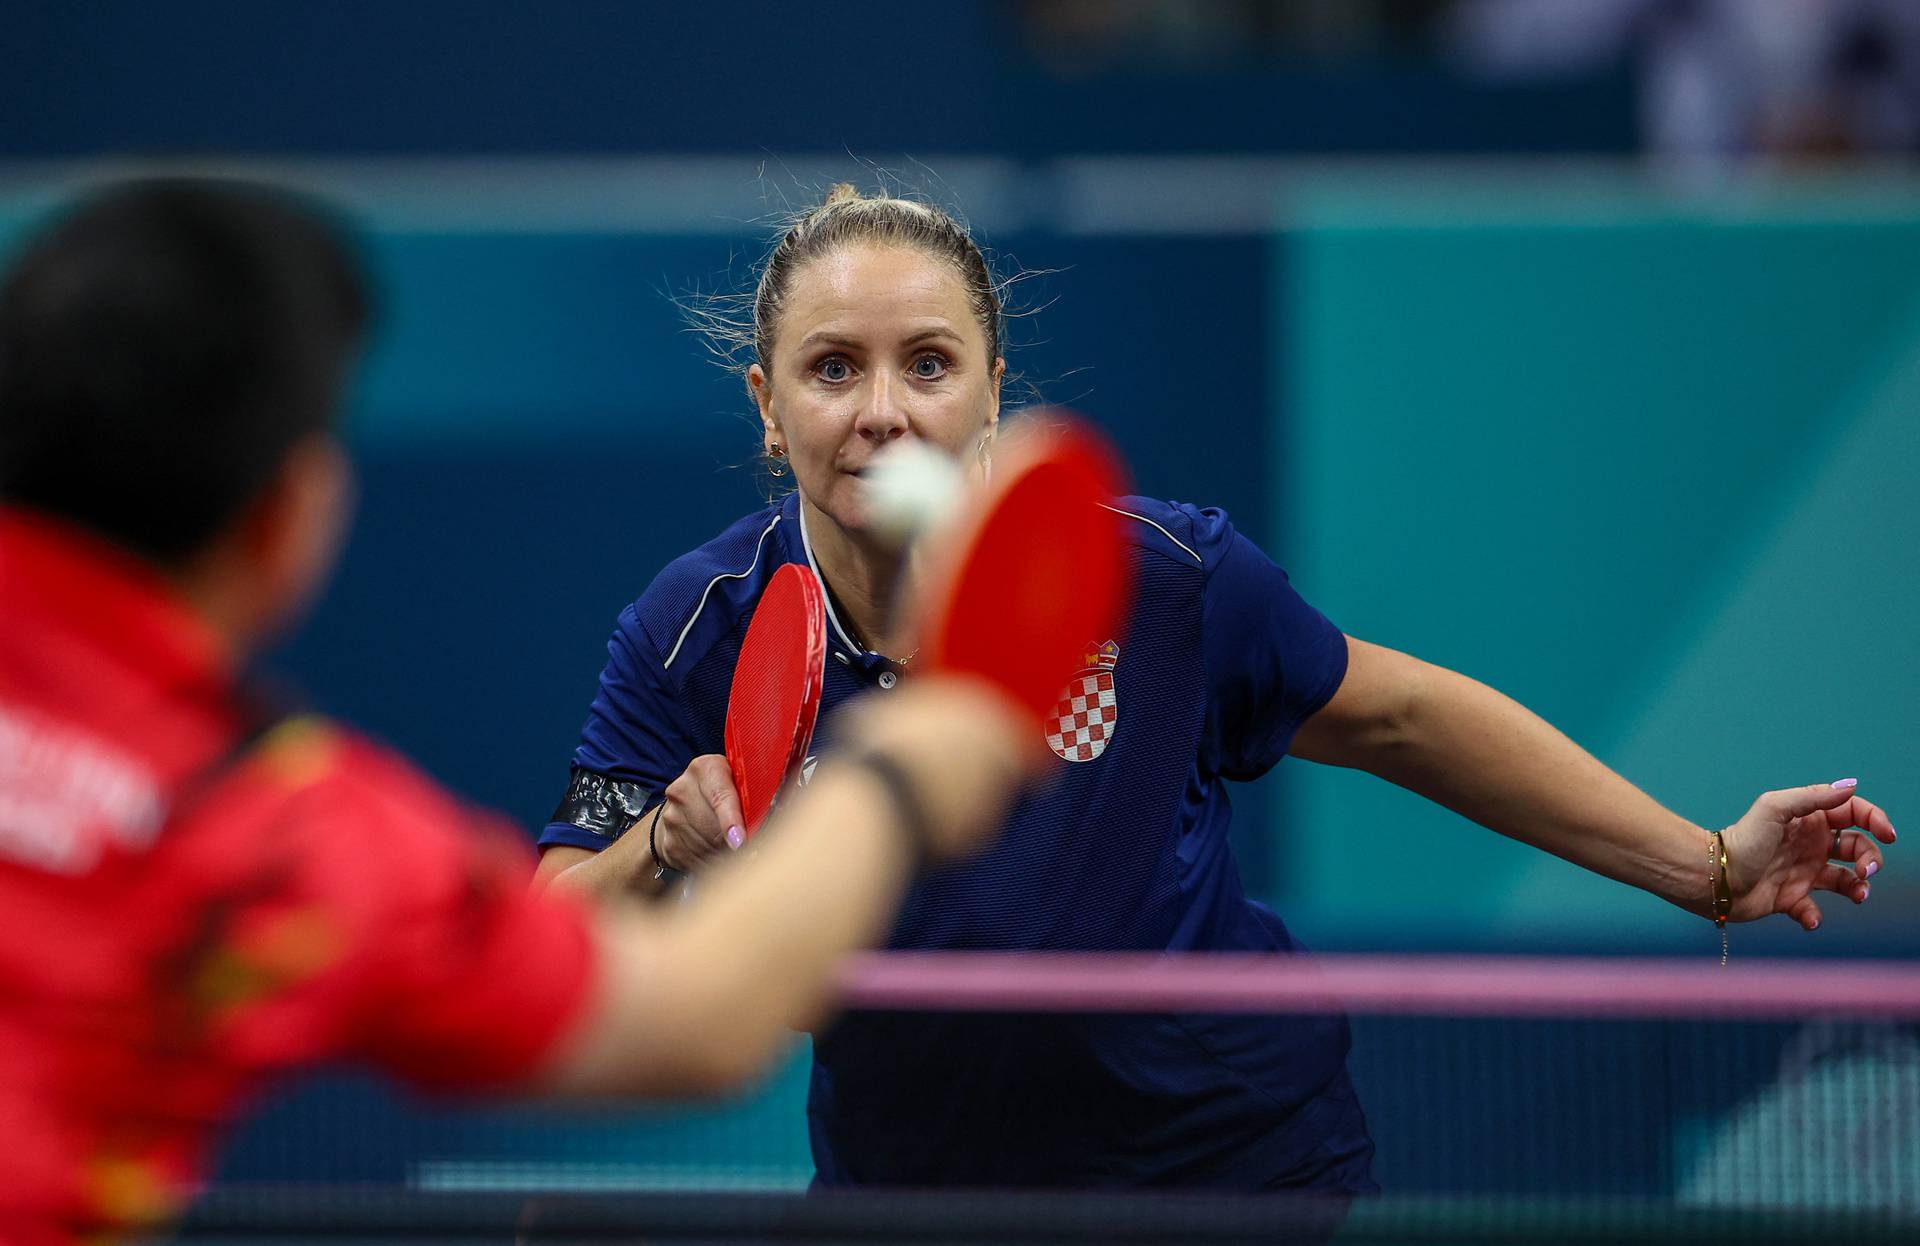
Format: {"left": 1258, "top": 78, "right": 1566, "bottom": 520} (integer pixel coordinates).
{"left": 549, "top": 680, "right": 1043, "bottom": 1094}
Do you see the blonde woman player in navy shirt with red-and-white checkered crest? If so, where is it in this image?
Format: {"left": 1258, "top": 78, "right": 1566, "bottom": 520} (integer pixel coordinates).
{"left": 541, "top": 186, "right": 1893, "bottom": 1192}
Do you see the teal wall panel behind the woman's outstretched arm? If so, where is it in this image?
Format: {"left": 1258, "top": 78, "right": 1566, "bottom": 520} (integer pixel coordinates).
{"left": 1271, "top": 180, "right": 1920, "bottom": 956}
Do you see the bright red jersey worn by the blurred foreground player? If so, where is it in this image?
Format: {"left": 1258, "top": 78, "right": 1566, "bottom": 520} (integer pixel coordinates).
{"left": 0, "top": 511, "right": 593, "bottom": 1242}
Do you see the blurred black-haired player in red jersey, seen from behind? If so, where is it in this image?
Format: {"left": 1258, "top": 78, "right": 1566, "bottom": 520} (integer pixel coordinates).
{"left": 0, "top": 180, "right": 1023, "bottom": 1242}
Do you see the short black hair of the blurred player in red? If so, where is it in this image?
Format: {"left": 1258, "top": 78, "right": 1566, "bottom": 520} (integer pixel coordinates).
{"left": 0, "top": 179, "right": 369, "bottom": 566}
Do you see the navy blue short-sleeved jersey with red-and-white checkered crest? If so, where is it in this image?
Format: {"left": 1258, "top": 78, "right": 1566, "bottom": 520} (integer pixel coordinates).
{"left": 540, "top": 495, "right": 1373, "bottom": 1192}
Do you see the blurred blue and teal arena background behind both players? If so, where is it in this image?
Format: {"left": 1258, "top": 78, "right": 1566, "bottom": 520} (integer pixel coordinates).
{"left": 0, "top": 0, "right": 1920, "bottom": 1221}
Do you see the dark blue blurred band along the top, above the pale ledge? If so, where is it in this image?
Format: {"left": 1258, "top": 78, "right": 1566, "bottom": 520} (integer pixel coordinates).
{"left": 0, "top": 0, "right": 1634, "bottom": 159}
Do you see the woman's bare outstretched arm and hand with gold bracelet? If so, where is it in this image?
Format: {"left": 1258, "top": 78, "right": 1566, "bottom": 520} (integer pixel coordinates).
{"left": 1292, "top": 637, "right": 1893, "bottom": 929}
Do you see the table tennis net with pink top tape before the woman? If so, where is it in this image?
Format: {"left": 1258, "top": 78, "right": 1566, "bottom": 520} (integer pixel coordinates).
{"left": 186, "top": 954, "right": 1920, "bottom": 1242}
